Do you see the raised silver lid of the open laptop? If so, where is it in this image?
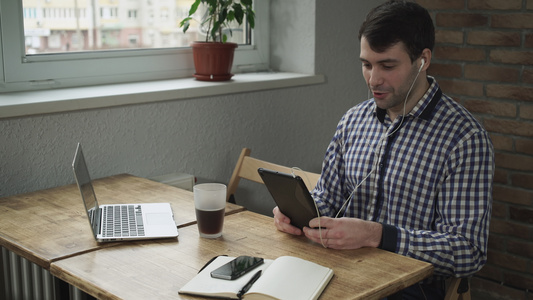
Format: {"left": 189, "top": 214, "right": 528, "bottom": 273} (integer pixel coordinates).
{"left": 72, "top": 143, "right": 100, "bottom": 238}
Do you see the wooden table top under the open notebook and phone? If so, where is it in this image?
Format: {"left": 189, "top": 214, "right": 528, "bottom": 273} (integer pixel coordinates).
{"left": 50, "top": 211, "right": 433, "bottom": 299}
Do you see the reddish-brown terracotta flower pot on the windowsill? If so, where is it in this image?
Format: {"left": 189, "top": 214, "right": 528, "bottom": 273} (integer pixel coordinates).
{"left": 192, "top": 42, "right": 238, "bottom": 81}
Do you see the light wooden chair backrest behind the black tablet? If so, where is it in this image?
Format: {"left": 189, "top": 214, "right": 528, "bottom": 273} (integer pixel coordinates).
{"left": 226, "top": 148, "right": 320, "bottom": 202}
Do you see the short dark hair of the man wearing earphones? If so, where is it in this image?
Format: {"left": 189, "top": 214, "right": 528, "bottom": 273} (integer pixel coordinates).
{"left": 359, "top": 1, "right": 435, "bottom": 62}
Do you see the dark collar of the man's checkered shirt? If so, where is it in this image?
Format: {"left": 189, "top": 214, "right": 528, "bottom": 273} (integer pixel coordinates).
{"left": 374, "top": 76, "right": 442, "bottom": 123}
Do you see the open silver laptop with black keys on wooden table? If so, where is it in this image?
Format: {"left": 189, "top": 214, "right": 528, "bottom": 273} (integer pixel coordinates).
{"left": 72, "top": 143, "right": 178, "bottom": 242}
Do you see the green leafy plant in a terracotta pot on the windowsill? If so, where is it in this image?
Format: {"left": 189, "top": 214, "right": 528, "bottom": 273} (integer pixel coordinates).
{"left": 180, "top": 0, "right": 255, "bottom": 81}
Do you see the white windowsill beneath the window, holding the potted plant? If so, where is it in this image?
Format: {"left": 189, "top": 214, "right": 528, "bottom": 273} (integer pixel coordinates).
{"left": 0, "top": 72, "right": 325, "bottom": 118}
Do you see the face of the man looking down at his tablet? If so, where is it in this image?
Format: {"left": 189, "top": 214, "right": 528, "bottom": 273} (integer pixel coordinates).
{"left": 360, "top": 36, "right": 420, "bottom": 119}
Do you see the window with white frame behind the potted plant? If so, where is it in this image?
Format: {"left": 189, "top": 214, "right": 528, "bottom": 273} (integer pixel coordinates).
{"left": 0, "top": 0, "right": 269, "bottom": 93}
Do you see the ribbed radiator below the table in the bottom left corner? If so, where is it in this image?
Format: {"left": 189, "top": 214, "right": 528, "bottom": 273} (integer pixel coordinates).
{"left": 0, "top": 247, "right": 92, "bottom": 300}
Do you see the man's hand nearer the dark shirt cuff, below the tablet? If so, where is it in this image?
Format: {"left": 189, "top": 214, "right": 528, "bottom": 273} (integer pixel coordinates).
{"left": 303, "top": 217, "right": 383, "bottom": 249}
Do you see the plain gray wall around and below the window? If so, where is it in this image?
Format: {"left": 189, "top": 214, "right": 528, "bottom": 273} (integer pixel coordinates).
{"left": 0, "top": 0, "right": 378, "bottom": 214}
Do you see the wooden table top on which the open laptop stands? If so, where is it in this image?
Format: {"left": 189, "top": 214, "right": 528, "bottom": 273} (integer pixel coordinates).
{"left": 0, "top": 174, "right": 244, "bottom": 269}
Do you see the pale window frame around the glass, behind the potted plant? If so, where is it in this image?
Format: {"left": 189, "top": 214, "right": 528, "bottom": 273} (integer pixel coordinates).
{"left": 0, "top": 0, "right": 270, "bottom": 93}
